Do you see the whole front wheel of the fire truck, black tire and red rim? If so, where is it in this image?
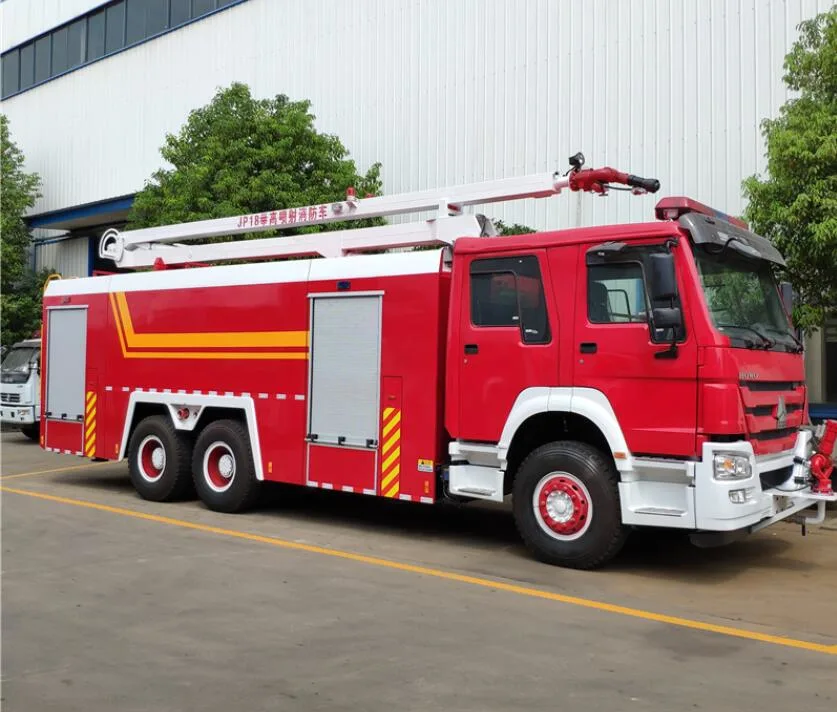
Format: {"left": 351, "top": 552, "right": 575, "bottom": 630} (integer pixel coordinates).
{"left": 513, "top": 441, "right": 628, "bottom": 569}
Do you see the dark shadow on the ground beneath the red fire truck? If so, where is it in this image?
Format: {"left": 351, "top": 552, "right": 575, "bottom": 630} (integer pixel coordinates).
{"left": 55, "top": 468, "right": 816, "bottom": 585}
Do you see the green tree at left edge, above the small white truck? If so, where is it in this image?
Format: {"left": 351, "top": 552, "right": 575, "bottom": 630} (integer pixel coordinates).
{"left": 0, "top": 114, "right": 42, "bottom": 346}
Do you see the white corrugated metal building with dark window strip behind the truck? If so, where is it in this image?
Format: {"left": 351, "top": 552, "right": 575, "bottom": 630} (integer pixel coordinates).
{"left": 0, "top": 0, "right": 837, "bottom": 401}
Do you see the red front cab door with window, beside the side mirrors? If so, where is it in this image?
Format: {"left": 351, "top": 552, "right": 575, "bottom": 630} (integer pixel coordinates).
{"left": 574, "top": 243, "right": 698, "bottom": 457}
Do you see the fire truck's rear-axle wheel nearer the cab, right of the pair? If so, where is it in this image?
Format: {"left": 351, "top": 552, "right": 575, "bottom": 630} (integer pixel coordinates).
{"left": 192, "top": 420, "right": 260, "bottom": 514}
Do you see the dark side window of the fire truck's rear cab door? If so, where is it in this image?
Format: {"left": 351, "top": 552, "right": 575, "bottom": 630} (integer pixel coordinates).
{"left": 470, "top": 255, "right": 551, "bottom": 344}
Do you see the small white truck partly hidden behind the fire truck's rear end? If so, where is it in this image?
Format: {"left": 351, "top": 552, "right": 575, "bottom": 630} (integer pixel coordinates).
{"left": 0, "top": 338, "right": 41, "bottom": 442}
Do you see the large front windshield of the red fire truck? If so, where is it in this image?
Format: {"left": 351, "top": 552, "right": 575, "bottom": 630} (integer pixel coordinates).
{"left": 695, "top": 245, "right": 799, "bottom": 351}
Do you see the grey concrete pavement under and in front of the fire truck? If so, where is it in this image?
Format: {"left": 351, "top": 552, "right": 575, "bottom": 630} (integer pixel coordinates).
{"left": 0, "top": 433, "right": 837, "bottom": 712}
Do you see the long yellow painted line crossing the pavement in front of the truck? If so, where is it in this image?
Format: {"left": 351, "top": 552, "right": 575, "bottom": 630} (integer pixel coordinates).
{"left": 0, "top": 484, "right": 837, "bottom": 655}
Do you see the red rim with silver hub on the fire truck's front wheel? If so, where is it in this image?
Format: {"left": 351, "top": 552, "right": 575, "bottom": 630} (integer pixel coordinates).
{"left": 532, "top": 473, "right": 593, "bottom": 539}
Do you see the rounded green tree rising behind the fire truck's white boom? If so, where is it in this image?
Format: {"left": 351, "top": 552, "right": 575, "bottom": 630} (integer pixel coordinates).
{"left": 128, "top": 83, "right": 381, "bottom": 232}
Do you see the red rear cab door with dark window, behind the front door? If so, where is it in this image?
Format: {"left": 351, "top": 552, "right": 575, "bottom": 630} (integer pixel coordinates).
{"left": 454, "top": 250, "right": 558, "bottom": 443}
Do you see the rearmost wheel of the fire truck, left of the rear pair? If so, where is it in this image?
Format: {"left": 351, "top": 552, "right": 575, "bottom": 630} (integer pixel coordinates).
{"left": 128, "top": 415, "right": 192, "bottom": 502}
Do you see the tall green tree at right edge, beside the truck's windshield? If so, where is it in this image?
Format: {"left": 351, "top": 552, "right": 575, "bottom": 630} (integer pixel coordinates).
{"left": 744, "top": 8, "right": 837, "bottom": 330}
